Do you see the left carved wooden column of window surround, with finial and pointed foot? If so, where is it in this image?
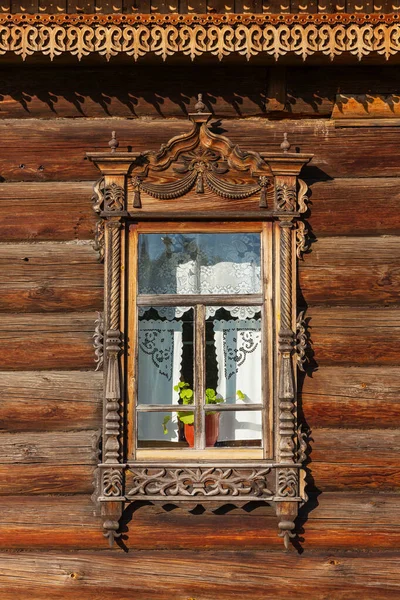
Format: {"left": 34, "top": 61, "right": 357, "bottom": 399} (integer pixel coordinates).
{"left": 89, "top": 137, "right": 135, "bottom": 546}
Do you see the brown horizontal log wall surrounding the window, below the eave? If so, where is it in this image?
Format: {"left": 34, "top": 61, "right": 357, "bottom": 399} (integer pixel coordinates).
{"left": 0, "top": 66, "right": 400, "bottom": 600}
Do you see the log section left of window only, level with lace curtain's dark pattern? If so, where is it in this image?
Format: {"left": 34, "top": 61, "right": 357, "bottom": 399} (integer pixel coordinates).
{"left": 0, "top": 313, "right": 96, "bottom": 370}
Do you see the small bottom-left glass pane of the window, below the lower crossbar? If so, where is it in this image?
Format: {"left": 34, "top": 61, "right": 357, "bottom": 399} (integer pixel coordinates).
{"left": 137, "top": 412, "right": 188, "bottom": 448}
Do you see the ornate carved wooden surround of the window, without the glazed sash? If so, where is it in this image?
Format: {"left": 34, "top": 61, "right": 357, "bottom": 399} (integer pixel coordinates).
{"left": 87, "top": 99, "right": 312, "bottom": 547}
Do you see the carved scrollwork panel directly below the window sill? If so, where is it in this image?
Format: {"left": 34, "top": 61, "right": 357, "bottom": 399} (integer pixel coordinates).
{"left": 127, "top": 466, "right": 273, "bottom": 499}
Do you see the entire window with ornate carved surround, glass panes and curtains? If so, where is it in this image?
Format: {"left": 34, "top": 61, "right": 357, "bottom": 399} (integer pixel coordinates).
{"left": 88, "top": 102, "right": 311, "bottom": 546}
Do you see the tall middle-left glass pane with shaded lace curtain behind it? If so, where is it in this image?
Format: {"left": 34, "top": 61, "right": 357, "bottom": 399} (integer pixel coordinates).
{"left": 138, "top": 306, "right": 193, "bottom": 404}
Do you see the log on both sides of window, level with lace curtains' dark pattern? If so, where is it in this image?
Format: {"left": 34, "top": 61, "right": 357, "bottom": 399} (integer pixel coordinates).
{"left": 0, "top": 307, "right": 400, "bottom": 370}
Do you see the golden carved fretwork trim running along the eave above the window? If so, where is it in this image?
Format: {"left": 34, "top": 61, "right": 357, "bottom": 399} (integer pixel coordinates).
{"left": 0, "top": 13, "right": 400, "bottom": 61}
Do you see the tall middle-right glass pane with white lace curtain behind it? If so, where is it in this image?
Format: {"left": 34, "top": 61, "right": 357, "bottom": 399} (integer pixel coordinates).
{"left": 206, "top": 306, "right": 262, "bottom": 406}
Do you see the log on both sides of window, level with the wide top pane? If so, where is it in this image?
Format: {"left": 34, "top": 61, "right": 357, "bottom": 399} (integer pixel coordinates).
{"left": 0, "top": 236, "right": 400, "bottom": 312}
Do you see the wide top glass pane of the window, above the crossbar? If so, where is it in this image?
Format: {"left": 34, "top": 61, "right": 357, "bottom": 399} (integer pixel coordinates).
{"left": 139, "top": 233, "right": 261, "bottom": 294}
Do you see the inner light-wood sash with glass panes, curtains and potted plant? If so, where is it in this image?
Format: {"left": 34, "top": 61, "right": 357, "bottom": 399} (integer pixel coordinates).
{"left": 132, "top": 223, "right": 270, "bottom": 460}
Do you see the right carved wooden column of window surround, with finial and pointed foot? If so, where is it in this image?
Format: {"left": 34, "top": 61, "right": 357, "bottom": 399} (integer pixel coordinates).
{"left": 263, "top": 139, "right": 311, "bottom": 548}
